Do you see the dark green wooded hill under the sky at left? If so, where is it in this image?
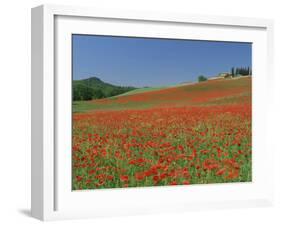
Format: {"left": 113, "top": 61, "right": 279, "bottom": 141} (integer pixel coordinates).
{"left": 72, "top": 77, "right": 136, "bottom": 100}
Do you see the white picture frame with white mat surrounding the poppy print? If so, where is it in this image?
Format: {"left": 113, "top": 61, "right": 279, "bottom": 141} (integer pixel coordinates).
{"left": 31, "top": 5, "right": 274, "bottom": 220}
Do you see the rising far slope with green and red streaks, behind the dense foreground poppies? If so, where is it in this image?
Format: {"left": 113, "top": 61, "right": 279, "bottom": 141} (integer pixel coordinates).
{"left": 73, "top": 77, "right": 251, "bottom": 112}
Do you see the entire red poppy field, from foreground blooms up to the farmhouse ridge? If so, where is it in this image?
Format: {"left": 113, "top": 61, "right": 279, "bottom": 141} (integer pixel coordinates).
{"left": 72, "top": 76, "right": 252, "bottom": 190}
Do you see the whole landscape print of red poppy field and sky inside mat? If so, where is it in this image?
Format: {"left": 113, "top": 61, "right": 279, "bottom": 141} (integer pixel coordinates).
{"left": 72, "top": 34, "right": 252, "bottom": 190}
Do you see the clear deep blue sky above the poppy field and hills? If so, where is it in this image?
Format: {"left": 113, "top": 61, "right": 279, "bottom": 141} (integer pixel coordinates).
{"left": 72, "top": 35, "right": 252, "bottom": 87}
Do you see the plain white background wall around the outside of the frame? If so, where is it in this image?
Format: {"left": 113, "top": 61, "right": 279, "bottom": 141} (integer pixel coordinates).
{"left": 0, "top": 0, "right": 281, "bottom": 226}
